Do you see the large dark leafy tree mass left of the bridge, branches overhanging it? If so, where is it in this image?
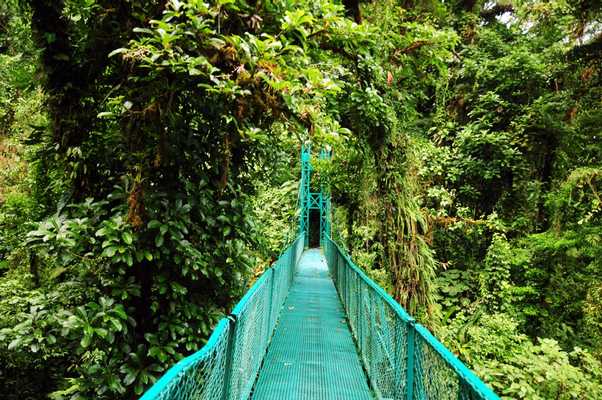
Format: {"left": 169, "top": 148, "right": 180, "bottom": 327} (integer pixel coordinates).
{"left": 5, "top": 1, "right": 384, "bottom": 399}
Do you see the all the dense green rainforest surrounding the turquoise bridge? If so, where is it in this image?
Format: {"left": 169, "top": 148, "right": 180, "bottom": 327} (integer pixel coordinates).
{"left": 0, "top": 0, "right": 602, "bottom": 399}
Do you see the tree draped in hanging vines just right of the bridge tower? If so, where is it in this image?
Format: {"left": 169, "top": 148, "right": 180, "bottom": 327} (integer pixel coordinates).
{"left": 312, "top": 2, "right": 455, "bottom": 314}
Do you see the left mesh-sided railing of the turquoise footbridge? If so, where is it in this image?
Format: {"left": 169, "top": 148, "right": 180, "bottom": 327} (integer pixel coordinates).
{"left": 141, "top": 234, "right": 304, "bottom": 400}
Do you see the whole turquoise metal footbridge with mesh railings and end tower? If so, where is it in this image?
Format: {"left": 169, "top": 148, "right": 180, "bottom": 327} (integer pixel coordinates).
{"left": 141, "top": 146, "right": 498, "bottom": 400}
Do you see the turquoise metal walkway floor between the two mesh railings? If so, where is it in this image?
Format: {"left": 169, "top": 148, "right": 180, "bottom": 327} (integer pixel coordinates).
{"left": 253, "top": 249, "right": 372, "bottom": 400}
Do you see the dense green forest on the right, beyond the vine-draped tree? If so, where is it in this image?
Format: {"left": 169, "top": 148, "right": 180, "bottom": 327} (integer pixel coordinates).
{"left": 419, "top": 1, "right": 602, "bottom": 399}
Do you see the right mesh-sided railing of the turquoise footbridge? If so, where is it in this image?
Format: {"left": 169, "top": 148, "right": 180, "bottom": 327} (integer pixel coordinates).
{"left": 325, "top": 237, "right": 499, "bottom": 400}
